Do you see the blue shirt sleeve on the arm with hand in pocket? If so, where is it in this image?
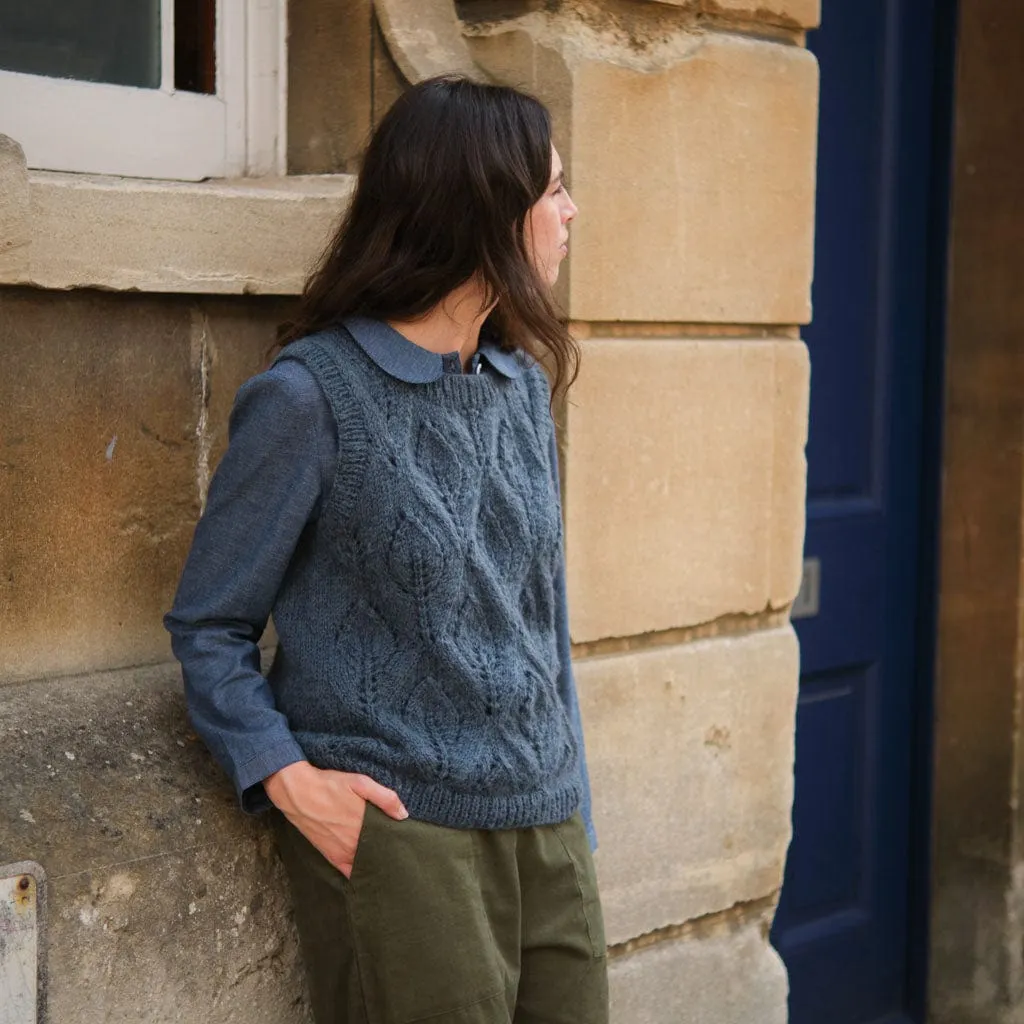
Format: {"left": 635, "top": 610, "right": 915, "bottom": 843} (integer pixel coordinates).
{"left": 164, "top": 359, "right": 337, "bottom": 813}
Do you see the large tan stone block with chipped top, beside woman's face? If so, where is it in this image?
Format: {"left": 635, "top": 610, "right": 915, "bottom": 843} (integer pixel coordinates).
{"left": 470, "top": 20, "right": 817, "bottom": 324}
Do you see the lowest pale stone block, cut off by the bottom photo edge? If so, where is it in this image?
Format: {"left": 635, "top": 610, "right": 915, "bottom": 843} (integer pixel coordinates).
{"left": 608, "top": 921, "right": 788, "bottom": 1024}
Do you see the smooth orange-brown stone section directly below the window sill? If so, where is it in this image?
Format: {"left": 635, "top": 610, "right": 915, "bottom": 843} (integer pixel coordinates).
{"left": 0, "top": 289, "right": 285, "bottom": 682}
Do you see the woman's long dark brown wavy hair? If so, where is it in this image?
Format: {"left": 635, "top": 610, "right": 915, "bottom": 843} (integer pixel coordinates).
{"left": 278, "top": 76, "right": 580, "bottom": 395}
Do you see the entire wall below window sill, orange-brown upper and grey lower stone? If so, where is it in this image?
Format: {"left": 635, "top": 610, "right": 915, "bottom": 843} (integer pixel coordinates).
{"left": 0, "top": 288, "right": 305, "bottom": 1024}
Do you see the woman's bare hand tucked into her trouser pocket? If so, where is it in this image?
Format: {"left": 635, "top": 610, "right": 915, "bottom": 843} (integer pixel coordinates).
{"left": 263, "top": 761, "right": 409, "bottom": 879}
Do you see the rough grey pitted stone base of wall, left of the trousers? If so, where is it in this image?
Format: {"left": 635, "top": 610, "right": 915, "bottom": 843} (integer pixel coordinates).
{"left": 0, "top": 667, "right": 308, "bottom": 1024}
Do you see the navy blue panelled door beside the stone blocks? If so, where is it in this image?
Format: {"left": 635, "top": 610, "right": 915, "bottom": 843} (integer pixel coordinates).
{"left": 772, "top": 0, "right": 938, "bottom": 1024}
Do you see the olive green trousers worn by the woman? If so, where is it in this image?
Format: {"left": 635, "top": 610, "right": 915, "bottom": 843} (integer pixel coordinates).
{"left": 274, "top": 804, "right": 608, "bottom": 1024}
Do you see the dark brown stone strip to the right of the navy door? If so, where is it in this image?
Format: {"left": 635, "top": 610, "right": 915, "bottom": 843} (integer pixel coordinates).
{"left": 929, "top": 0, "right": 1024, "bottom": 1024}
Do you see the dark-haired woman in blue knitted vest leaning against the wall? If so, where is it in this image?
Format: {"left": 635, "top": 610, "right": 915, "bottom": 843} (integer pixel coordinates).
{"left": 166, "top": 78, "right": 607, "bottom": 1024}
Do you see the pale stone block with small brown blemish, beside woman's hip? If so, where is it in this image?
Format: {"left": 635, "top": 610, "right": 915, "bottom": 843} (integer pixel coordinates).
{"left": 575, "top": 627, "right": 799, "bottom": 942}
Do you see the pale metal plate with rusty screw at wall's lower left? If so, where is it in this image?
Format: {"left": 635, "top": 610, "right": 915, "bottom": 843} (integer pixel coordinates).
{"left": 0, "top": 861, "right": 46, "bottom": 1024}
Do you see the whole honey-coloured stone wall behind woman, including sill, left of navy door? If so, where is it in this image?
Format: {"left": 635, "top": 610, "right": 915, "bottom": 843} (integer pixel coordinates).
{"left": 0, "top": 0, "right": 818, "bottom": 1024}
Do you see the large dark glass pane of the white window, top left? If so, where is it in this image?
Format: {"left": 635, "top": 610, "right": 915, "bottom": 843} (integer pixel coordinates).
{"left": 0, "top": 0, "right": 160, "bottom": 89}
